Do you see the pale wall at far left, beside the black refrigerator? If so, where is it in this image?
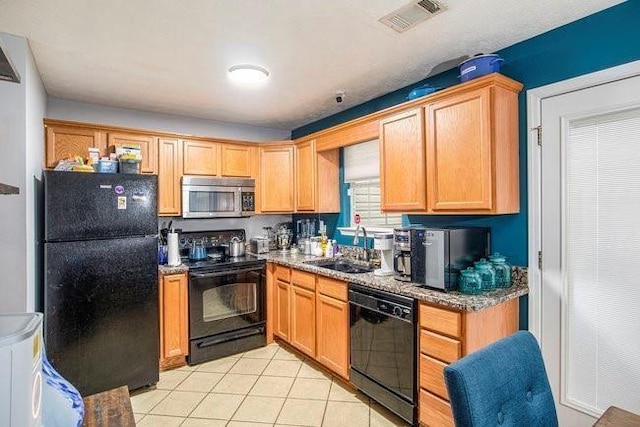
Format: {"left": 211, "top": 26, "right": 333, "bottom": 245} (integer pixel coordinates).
{"left": 0, "top": 33, "right": 46, "bottom": 312}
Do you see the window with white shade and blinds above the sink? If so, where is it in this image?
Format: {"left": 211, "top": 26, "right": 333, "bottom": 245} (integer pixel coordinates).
{"left": 341, "top": 139, "right": 402, "bottom": 234}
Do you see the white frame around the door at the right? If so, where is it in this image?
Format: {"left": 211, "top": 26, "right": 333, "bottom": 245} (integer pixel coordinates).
{"left": 527, "top": 61, "right": 640, "bottom": 342}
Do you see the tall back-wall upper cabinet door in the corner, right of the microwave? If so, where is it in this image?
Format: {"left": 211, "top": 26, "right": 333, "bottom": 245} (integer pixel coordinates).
{"left": 260, "top": 145, "right": 295, "bottom": 212}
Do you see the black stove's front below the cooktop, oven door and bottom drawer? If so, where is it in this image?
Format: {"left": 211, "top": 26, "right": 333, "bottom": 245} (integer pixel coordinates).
{"left": 189, "top": 266, "right": 266, "bottom": 364}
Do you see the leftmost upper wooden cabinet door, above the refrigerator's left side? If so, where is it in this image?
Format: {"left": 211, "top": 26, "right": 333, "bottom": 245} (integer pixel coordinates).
{"left": 45, "top": 125, "right": 107, "bottom": 168}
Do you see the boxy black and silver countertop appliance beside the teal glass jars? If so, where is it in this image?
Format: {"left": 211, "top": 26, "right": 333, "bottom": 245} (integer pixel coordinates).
{"left": 411, "top": 227, "right": 490, "bottom": 291}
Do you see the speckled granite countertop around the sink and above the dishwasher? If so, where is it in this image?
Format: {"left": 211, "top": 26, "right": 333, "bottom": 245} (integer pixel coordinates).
{"left": 259, "top": 252, "right": 529, "bottom": 311}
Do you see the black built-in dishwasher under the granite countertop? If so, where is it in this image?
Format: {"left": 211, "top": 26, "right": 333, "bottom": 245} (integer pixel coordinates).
{"left": 349, "top": 283, "right": 417, "bottom": 424}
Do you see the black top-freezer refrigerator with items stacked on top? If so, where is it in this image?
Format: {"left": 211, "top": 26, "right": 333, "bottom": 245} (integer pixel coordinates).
{"left": 43, "top": 171, "right": 159, "bottom": 396}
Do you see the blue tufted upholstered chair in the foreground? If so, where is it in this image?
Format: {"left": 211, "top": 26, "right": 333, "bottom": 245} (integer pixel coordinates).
{"left": 444, "top": 331, "right": 558, "bottom": 427}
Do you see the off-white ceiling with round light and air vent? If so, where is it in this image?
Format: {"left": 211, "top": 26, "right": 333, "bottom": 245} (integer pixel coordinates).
{"left": 0, "top": 0, "right": 621, "bottom": 130}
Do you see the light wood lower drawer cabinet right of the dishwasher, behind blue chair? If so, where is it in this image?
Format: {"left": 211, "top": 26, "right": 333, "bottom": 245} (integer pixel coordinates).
{"left": 418, "top": 299, "right": 518, "bottom": 426}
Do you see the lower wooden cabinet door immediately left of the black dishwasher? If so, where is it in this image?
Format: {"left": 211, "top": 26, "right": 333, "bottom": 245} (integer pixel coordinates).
{"left": 316, "top": 294, "right": 349, "bottom": 379}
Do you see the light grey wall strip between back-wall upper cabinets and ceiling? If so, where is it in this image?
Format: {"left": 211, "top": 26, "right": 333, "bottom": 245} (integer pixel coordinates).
{"left": 47, "top": 98, "right": 291, "bottom": 141}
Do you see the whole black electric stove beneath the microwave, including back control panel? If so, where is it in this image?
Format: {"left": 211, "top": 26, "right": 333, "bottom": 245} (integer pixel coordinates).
{"left": 179, "top": 230, "right": 266, "bottom": 365}
